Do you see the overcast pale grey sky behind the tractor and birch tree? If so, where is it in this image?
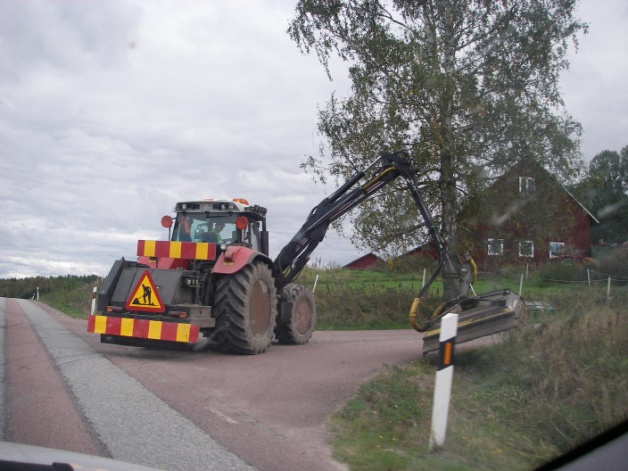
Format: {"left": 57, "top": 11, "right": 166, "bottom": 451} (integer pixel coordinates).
{"left": 0, "top": 0, "right": 628, "bottom": 278}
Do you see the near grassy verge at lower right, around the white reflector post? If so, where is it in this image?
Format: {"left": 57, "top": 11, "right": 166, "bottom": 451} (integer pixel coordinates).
{"left": 330, "top": 288, "right": 628, "bottom": 470}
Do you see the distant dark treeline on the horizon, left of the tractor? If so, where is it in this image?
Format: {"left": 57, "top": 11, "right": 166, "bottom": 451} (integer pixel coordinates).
{"left": 0, "top": 275, "right": 100, "bottom": 299}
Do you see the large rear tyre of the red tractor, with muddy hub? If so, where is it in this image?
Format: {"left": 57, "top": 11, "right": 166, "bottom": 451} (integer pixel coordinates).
{"left": 212, "top": 262, "right": 277, "bottom": 355}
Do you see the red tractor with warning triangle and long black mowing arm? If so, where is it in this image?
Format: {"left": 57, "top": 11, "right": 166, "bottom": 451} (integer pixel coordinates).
{"left": 88, "top": 153, "right": 525, "bottom": 354}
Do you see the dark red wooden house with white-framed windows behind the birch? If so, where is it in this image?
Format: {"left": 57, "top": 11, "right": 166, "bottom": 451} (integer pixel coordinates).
{"left": 459, "top": 160, "right": 598, "bottom": 268}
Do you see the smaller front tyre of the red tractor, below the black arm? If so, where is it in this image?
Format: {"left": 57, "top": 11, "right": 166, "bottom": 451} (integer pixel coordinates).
{"left": 275, "top": 283, "right": 316, "bottom": 345}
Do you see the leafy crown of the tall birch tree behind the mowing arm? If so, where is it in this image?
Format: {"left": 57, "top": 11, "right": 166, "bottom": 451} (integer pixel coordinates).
{"left": 289, "top": 0, "right": 586, "bottom": 262}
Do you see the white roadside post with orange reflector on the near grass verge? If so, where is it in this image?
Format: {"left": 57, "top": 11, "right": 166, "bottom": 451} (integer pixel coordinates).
{"left": 430, "top": 314, "right": 458, "bottom": 451}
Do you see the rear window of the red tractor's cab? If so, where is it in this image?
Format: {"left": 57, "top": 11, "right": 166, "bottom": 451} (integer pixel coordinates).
{"left": 172, "top": 212, "right": 237, "bottom": 244}
